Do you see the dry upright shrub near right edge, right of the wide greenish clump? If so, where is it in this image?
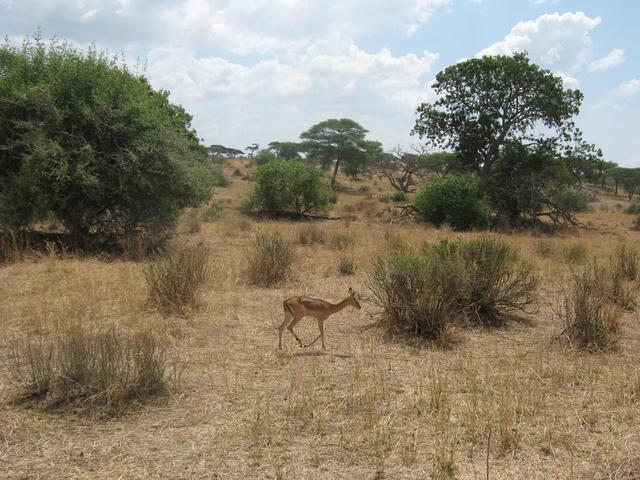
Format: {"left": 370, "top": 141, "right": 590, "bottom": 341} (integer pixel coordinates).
{"left": 559, "top": 263, "right": 621, "bottom": 350}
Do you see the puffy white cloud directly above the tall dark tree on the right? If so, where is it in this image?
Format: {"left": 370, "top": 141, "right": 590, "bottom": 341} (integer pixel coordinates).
{"left": 478, "top": 12, "right": 601, "bottom": 77}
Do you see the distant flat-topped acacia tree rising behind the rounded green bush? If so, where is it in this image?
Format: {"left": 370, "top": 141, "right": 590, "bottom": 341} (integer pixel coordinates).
{"left": 300, "top": 118, "right": 382, "bottom": 186}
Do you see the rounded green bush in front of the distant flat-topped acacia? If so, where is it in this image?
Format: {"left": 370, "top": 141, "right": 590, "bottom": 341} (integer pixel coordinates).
{"left": 249, "top": 160, "right": 329, "bottom": 215}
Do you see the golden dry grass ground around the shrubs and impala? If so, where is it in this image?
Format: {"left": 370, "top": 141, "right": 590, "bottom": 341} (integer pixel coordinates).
{"left": 0, "top": 162, "right": 640, "bottom": 480}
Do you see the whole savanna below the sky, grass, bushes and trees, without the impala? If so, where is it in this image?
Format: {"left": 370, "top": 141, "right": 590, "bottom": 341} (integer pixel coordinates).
{"left": 0, "top": 38, "right": 640, "bottom": 480}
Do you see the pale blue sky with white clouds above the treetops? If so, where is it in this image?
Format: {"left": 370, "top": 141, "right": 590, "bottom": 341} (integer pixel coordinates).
{"left": 0, "top": 0, "right": 640, "bottom": 166}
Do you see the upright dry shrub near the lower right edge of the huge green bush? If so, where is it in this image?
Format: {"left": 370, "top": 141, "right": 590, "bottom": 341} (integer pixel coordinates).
{"left": 144, "top": 243, "right": 211, "bottom": 315}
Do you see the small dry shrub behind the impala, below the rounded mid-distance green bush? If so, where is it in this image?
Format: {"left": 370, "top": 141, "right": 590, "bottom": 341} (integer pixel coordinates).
{"left": 247, "top": 232, "right": 294, "bottom": 287}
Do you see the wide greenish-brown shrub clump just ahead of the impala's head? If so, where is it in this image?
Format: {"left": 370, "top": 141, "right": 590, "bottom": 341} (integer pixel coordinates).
{"left": 371, "top": 237, "right": 538, "bottom": 344}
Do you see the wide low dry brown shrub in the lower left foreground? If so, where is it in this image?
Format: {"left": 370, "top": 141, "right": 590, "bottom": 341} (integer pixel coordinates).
{"left": 7, "top": 323, "right": 167, "bottom": 416}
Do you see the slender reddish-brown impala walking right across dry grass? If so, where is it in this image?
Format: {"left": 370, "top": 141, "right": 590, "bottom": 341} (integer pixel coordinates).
{"left": 278, "top": 288, "right": 361, "bottom": 350}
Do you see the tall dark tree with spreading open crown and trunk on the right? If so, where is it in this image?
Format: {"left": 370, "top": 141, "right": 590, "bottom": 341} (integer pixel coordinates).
{"left": 412, "top": 53, "right": 583, "bottom": 186}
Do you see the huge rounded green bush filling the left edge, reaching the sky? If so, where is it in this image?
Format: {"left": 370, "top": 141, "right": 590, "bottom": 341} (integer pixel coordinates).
{"left": 0, "top": 38, "right": 215, "bottom": 248}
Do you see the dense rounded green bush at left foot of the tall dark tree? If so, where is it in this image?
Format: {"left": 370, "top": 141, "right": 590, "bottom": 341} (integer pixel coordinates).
{"left": 413, "top": 175, "right": 489, "bottom": 230}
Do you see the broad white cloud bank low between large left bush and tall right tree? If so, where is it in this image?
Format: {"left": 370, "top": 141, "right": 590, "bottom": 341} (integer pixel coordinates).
{"left": 147, "top": 39, "right": 438, "bottom": 148}
